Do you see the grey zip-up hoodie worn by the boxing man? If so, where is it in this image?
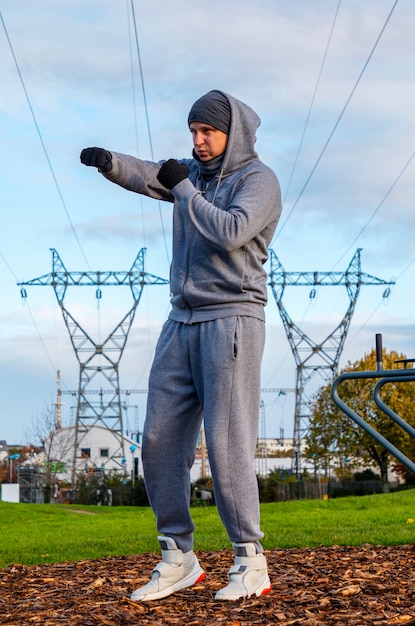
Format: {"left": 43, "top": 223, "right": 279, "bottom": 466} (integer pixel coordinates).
{"left": 104, "top": 92, "right": 281, "bottom": 323}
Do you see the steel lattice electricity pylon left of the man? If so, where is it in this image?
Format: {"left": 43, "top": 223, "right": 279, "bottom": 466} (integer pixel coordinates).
{"left": 18, "top": 248, "right": 169, "bottom": 482}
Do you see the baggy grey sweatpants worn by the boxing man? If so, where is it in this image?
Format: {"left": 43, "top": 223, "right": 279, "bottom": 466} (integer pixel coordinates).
{"left": 142, "top": 316, "right": 265, "bottom": 552}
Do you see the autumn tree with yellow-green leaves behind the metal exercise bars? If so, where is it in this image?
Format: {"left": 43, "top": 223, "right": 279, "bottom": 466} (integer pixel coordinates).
{"left": 305, "top": 349, "right": 415, "bottom": 490}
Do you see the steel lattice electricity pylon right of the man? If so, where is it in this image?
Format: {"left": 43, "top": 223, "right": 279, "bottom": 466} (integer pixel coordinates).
{"left": 269, "top": 248, "right": 394, "bottom": 476}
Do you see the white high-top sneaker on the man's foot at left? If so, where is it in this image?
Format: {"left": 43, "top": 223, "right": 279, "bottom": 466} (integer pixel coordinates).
{"left": 131, "top": 537, "right": 206, "bottom": 602}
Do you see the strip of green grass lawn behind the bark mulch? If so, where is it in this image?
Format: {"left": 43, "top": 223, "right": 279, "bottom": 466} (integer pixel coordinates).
{"left": 0, "top": 490, "right": 415, "bottom": 567}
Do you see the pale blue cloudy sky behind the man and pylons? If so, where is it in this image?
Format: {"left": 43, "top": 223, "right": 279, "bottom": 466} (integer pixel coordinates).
{"left": 0, "top": 0, "right": 415, "bottom": 443}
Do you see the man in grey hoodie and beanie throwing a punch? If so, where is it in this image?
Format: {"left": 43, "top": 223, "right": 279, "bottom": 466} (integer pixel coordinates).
{"left": 81, "top": 90, "right": 281, "bottom": 601}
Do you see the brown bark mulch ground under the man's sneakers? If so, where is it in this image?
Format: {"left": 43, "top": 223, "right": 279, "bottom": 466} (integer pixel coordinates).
{"left": 0, "top": 545, "right": 415, "bottom": 626}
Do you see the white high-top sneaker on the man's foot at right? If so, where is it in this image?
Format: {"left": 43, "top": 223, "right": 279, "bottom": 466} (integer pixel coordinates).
{"left": 215, "top": 543, "right": 272, "bottom": 600}
